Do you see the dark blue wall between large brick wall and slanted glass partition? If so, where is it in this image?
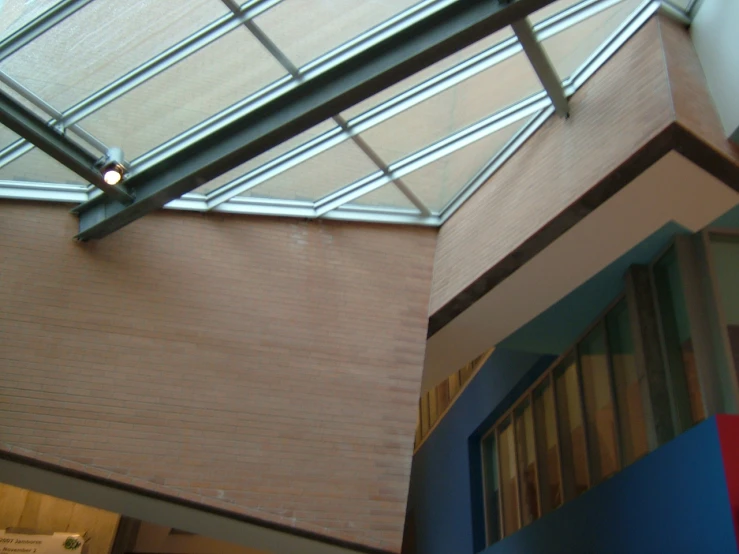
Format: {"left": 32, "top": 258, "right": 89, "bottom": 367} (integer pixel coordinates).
{"left": 409, "top": 349, "right": 553, "bottom": 554}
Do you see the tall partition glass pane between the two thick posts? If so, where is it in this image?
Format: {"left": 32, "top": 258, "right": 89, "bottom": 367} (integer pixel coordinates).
{"left": 654, "top": 248, "right": 706, "bottom": 431}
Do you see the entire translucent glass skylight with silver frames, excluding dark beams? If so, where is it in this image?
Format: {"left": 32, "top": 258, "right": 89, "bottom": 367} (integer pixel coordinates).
{"left": 0, "top": 0, "right": 689, "bottom": 225}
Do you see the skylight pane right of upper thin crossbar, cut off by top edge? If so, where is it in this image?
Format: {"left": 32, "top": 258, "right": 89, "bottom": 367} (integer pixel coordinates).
{"left": 255, "top": 0, "right": 418, "bottom": 66}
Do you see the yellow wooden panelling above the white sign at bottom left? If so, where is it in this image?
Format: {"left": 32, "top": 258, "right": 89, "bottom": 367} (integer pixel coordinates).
{"left": 0, "top": 483, "right": 119, "bottom": 554}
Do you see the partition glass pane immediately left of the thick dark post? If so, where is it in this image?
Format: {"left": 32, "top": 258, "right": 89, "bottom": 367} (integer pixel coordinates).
{"left": 606, "top": 300, "right": 649, "bottom": 464}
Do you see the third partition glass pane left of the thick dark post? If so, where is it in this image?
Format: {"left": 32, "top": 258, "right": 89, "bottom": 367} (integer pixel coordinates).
{"left": 554, "top": 358, "right": 589, "bottom": 500}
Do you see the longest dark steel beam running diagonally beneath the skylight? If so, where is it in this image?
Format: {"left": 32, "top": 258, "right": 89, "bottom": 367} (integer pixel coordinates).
{"left": 77, "top": 0, "right": 552, "bottom": 240}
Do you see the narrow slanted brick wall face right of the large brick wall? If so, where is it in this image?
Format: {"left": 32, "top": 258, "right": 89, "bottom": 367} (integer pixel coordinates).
{"left": 429, "top": 18, "right": 674, "bottom": 315}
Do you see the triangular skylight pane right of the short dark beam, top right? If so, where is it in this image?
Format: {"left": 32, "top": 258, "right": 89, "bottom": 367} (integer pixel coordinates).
{"left": 543, "top": 0, "right": 642, "bottom": 79}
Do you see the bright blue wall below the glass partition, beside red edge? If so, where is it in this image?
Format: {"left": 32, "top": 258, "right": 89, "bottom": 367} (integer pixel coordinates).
{"left": 485, "top": 418, "right": 737, "bottom": 554}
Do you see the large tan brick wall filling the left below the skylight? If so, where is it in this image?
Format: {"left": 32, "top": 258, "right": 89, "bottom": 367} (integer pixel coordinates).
{"left": 0, "top": 202, "right": 436, "bottom": 551}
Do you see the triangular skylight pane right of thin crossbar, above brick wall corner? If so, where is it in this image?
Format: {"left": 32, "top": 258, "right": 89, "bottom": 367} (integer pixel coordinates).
{"left": 403, "top": 120, "right": 526, "bottom": 212}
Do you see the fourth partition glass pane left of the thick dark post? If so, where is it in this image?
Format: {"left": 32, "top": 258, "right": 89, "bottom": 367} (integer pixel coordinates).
{"left": 534, "top": 380, "right": 562, "bottom": 514}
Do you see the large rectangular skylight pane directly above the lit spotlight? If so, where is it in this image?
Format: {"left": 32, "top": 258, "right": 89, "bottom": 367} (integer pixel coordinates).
{"left": 82, "top": 30, "right": 286, "bottom": 160}
